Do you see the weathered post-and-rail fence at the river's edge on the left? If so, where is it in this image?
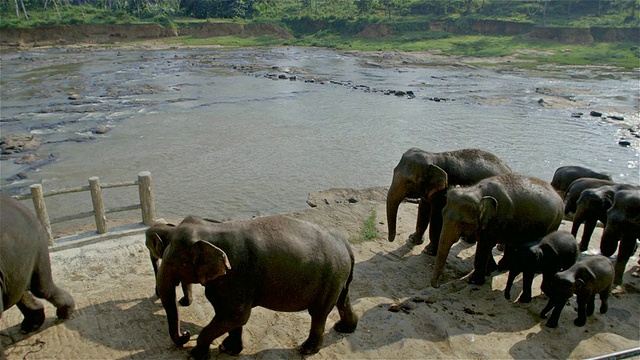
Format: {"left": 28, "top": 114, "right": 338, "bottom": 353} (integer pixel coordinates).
{"left": 15, "top": 171, "right": 156, "bottom": 245}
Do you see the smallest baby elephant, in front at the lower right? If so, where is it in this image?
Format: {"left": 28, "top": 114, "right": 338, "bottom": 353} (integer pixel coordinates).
{"left": 540, "top": 255, "right": 614, "bottom": 328}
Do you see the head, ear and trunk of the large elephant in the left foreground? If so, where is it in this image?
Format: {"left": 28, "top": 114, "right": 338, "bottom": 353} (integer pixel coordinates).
{"left": 156, "top": 224, "right": 231, "bottom": 346}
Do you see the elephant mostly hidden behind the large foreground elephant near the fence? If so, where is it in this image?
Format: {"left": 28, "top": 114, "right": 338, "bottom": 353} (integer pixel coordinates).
{"left": 145, "top": 216, "right": 220, "bottom": 306}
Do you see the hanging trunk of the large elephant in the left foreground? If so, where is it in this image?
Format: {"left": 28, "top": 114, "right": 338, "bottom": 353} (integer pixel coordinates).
{"left": 156, "top": 262, "right": 191, "bottom": 347}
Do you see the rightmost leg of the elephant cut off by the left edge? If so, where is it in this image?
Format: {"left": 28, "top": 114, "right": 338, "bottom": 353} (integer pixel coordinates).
{"left": 30, "top": 264, "right": 75, "bottom": 319}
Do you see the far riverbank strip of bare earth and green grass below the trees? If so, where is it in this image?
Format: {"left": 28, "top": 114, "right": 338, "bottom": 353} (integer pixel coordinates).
{"left": 0, "top": 21, "right": 640, "bottom": 72}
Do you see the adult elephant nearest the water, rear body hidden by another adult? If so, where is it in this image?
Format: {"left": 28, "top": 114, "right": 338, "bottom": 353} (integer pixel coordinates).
{"left": 387, "top": 148, "right": 511, "bottom": 255}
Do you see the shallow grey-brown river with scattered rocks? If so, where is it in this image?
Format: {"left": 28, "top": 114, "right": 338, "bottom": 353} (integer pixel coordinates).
{"left": 0, "top": 48, "right": 640, "bottom": 219}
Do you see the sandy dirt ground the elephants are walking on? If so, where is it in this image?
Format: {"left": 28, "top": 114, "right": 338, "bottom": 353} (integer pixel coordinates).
{"left": 0, "top": 189, "right": 640, "bottom": 359}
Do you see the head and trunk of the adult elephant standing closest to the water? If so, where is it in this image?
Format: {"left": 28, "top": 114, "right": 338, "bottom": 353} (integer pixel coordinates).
{"left": 387, "top": 151, "right": 448, "bottom": 241}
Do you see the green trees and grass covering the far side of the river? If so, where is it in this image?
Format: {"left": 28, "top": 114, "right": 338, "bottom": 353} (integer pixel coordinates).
{"left": 0, "top": 0, "right": 640, "bottom": 68}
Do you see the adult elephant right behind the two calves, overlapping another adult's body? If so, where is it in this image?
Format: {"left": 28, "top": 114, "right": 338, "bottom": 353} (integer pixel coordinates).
{"left": 431, "top": 170, "right": 562, "bottom": 287}
